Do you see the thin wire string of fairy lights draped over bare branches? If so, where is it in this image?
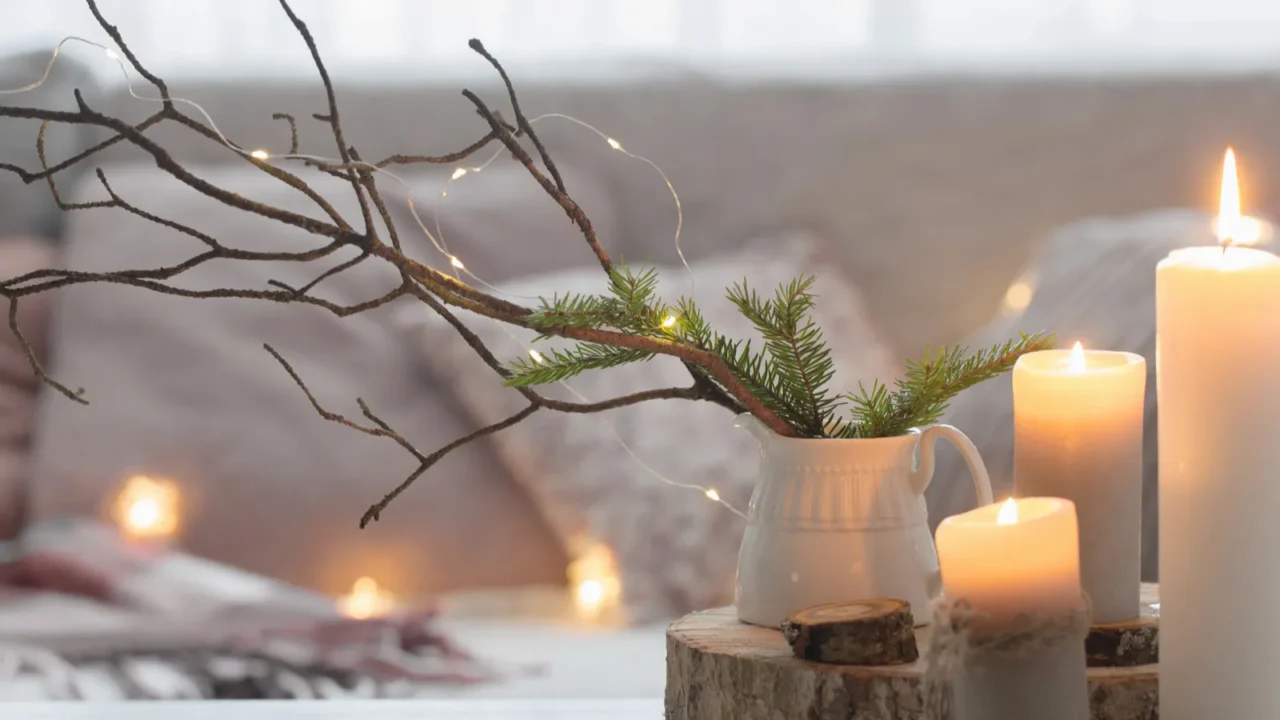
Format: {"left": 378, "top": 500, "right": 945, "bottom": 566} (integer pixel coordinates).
{"left": 0, "top": 36, "right": 746, "bottom": 519}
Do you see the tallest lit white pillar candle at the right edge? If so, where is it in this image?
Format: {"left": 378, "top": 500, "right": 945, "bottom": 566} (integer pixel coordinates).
{"left": 1156, "top": 151, "right": 1280, "bottom": 720}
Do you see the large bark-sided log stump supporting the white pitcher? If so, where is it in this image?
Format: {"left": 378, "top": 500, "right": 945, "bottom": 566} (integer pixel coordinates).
{"left": 666, "top": 585, "right": 1160, "bottom": 720}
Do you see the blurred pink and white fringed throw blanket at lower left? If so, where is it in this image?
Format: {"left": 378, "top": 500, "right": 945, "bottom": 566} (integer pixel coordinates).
{"left": 0, "top": 521, "right": 519, "bottom": 685}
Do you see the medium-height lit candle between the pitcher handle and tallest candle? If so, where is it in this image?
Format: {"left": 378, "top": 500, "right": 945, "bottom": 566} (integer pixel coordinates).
{"left": 1014, "top": 343, "right": 1147, "bottom": 623}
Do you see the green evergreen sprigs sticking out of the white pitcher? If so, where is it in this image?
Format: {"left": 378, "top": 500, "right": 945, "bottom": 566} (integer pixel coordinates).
{"left": 506, "top": 265, "right": 1053, "bottom": 438}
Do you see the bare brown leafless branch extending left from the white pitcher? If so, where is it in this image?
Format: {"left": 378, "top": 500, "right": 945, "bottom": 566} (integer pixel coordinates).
{"left": 0, "top": 0, "right": 794, "bottom": 527}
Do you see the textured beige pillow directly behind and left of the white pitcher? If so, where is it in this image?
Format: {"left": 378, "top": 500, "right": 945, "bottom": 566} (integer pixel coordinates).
{"left": 404, "top": 229, "right": 896, "bottom": 621}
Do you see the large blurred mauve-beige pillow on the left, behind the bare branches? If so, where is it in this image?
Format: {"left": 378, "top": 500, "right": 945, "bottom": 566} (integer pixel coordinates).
{"left": 24, "top": 165, "right": 609, "bottom": 596}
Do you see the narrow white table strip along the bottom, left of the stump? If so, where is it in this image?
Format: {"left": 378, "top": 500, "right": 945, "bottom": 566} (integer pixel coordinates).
{"left": 0, "top": 698, "right": 662, "bottom": 720}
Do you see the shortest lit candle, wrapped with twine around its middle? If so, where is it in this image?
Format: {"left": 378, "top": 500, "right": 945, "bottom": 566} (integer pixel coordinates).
{"left": 937, "top": 497, "right": 1089, "bottom": 720}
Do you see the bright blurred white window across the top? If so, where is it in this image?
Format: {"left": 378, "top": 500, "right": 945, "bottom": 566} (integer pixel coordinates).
{"left": 0, "top": 0, "right": 1280, "bottom": 79}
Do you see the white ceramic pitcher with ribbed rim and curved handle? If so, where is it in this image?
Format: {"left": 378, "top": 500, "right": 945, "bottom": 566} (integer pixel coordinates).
{"left": 737, "top": 415, "right": 992, "bottom": 628}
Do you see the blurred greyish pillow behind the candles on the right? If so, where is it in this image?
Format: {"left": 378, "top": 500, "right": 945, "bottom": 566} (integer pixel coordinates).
{"left": 925, "top": 211, "right": 1213, "bottom": 580}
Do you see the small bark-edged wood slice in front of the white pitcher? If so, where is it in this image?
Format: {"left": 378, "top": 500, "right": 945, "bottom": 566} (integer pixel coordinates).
{"left": 782, "top": 598, "right": 920, "bottom": 665}
